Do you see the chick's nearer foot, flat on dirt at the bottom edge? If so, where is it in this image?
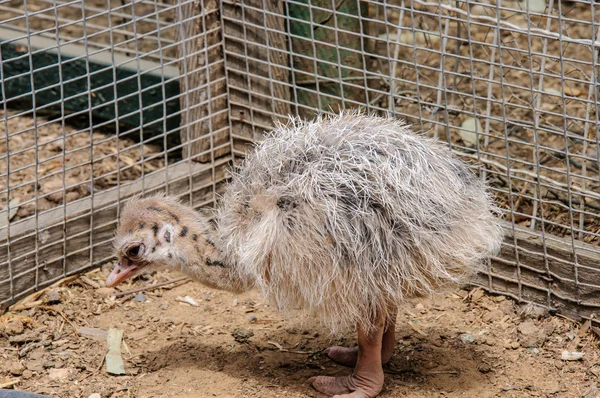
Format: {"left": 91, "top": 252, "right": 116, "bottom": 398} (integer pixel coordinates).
{"left": 308, "top": 370, "right": 383, "bottom": 398}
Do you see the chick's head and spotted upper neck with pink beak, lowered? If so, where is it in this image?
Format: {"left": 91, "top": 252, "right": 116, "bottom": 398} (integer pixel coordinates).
{"left": 106, "top": 196, "right": 239, "bottom": 290}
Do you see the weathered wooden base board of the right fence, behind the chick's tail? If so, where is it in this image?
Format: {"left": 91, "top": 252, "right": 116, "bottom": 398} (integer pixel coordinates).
{"left": 473, "top": 221, "right": 600, "bottom": 320}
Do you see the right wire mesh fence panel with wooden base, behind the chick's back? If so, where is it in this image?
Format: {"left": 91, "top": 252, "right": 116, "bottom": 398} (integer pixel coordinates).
{"left": 222, "top": 0, "right": 600, "bottom": 317}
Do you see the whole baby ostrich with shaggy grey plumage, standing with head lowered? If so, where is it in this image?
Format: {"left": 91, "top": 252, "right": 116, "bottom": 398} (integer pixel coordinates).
{"left": 106, "top": 114, "right": 502, "bottom": 398}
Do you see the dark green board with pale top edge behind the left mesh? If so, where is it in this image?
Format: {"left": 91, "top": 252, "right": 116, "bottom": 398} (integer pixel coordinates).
{"left": 0, "top": 28, "right": 180, "bottom": 146}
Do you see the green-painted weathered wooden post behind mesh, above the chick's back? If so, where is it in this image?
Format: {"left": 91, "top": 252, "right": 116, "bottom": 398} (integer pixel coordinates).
{"left": 288, "top": 0, "right": 370, "bottom": 118}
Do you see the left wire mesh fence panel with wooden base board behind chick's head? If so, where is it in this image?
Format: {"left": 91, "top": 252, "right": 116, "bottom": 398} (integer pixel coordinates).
{"left": 0, "top": 0, "right": 229, "bottom": 306}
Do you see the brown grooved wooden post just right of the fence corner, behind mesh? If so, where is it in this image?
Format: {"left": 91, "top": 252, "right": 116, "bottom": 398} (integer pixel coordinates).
{"left": 222, "top": 0, "right": 291, "bottom": 154}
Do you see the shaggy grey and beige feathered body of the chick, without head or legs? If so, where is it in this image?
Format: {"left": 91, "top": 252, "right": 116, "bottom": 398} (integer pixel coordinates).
{"left": 217, "top": 114, "right": 502, "bottom": 332}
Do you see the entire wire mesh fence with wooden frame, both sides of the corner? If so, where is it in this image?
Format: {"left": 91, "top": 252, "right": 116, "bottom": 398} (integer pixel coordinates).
{"left": 0, "top": 0, "right": 600, "bottom": 318}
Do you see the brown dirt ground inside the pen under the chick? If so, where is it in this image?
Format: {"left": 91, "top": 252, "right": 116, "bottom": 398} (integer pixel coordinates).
{"left": 0, "top": 265, "right": 600, "bottom": 398}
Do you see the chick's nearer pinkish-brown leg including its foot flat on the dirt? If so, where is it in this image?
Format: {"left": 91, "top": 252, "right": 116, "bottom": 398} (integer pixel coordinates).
{"left": 308, "top": 320, "right": 385, "bottom": 398}
